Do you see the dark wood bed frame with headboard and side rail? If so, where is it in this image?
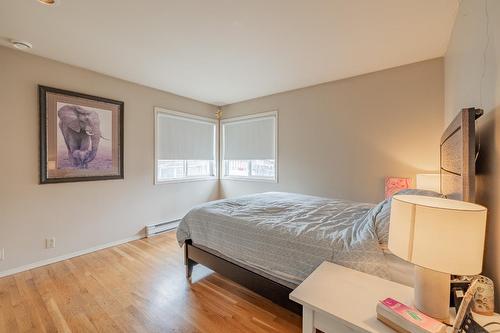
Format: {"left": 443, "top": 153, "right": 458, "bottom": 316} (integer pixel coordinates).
{"left": 184, "top": 108, "right": 483, "bottom": 314}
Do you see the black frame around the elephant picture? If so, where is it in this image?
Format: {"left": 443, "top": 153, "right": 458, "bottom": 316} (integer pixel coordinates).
{"left": 38, "top": 85, "right": 125, "bottom": 184}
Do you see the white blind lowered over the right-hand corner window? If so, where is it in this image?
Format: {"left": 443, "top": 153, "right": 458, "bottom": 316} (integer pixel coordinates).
{"left": 222, "top": 115, "right": 276, "bottom": 160}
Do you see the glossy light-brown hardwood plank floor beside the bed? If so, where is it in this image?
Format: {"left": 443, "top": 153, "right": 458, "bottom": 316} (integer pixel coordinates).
{"left": 0, "top": 232, "right": 301, "bottom": 333}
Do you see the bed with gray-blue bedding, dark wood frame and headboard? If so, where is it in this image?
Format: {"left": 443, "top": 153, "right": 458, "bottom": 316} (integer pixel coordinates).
{"left": 177, "top": 109, "right": 481, "bottom": 314}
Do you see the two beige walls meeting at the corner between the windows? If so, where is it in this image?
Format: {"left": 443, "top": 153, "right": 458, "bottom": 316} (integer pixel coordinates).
{"left": 0, "top": 44, "right": 443, "bottom": 275}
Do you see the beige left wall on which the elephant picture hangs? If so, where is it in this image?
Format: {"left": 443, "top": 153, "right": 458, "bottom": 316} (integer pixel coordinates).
{"left": 0, "top": 47, "right": 218, "bottom": 274}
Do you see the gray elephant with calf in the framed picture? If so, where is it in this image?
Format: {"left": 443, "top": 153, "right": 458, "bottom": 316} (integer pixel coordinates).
{"left": 57, "top": 105, "right": 102, "bottom": 169}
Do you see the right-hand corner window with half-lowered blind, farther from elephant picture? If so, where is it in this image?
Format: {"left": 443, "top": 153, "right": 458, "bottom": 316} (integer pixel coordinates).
{"left": 221, "top": 112, "right": 278, "bottom": 181}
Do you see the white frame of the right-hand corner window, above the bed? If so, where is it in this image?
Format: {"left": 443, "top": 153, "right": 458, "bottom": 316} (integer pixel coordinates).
{"left": 219, "top": 109, "right": 279, "bottom": 183}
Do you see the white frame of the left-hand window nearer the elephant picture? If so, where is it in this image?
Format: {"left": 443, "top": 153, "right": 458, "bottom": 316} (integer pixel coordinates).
{"left": 153, "top": 106, "right": 219, "bottom": 185}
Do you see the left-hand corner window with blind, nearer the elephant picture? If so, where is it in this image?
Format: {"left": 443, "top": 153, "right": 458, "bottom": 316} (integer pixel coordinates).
{"left": 155, "top": 108, "right": 217, "bottom": 183}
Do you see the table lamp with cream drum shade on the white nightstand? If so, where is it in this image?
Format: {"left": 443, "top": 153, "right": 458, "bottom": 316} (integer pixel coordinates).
{"left": 389, "top": 195, "right": 486, "bottom": 321}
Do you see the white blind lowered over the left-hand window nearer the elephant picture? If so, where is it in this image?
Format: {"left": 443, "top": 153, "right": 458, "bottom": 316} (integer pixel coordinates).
{"left": 157, "top": 112, "right": 215, "bottom": 160}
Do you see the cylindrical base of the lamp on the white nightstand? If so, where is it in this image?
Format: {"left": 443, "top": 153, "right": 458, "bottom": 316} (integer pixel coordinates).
{"left": 415, "top": 266, "right": 450, "bottom": 322}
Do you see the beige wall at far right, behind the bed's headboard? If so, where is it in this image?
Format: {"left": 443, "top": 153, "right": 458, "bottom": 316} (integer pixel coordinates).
{"left": 445, "top": 0, "right": 500, "bottom": 307}
